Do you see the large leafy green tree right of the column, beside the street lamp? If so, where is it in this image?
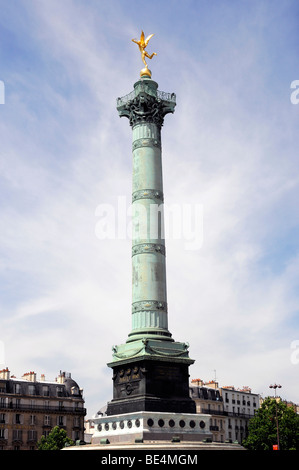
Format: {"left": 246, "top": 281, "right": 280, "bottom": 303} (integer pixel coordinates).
{"left": 243, "top": 397, "right": 299, "bottom": 450}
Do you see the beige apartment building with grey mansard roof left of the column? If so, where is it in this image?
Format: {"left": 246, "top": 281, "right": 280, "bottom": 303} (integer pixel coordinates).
{"left": 0, "top": 368, "right": 86, "bottom": 450}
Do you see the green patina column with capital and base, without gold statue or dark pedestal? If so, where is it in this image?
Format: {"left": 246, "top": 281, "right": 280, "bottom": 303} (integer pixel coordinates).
{"left": 108, "top": 77, "right": 194, "bottom": 367}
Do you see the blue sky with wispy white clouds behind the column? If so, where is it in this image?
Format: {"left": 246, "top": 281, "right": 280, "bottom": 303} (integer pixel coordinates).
{"left": 0, "top": 0, "right": 299, "bottom": 416}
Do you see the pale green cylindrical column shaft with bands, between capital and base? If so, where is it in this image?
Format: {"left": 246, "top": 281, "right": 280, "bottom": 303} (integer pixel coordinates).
{"left": 129, "top": 122, "right": 171, "bottom": 340}
